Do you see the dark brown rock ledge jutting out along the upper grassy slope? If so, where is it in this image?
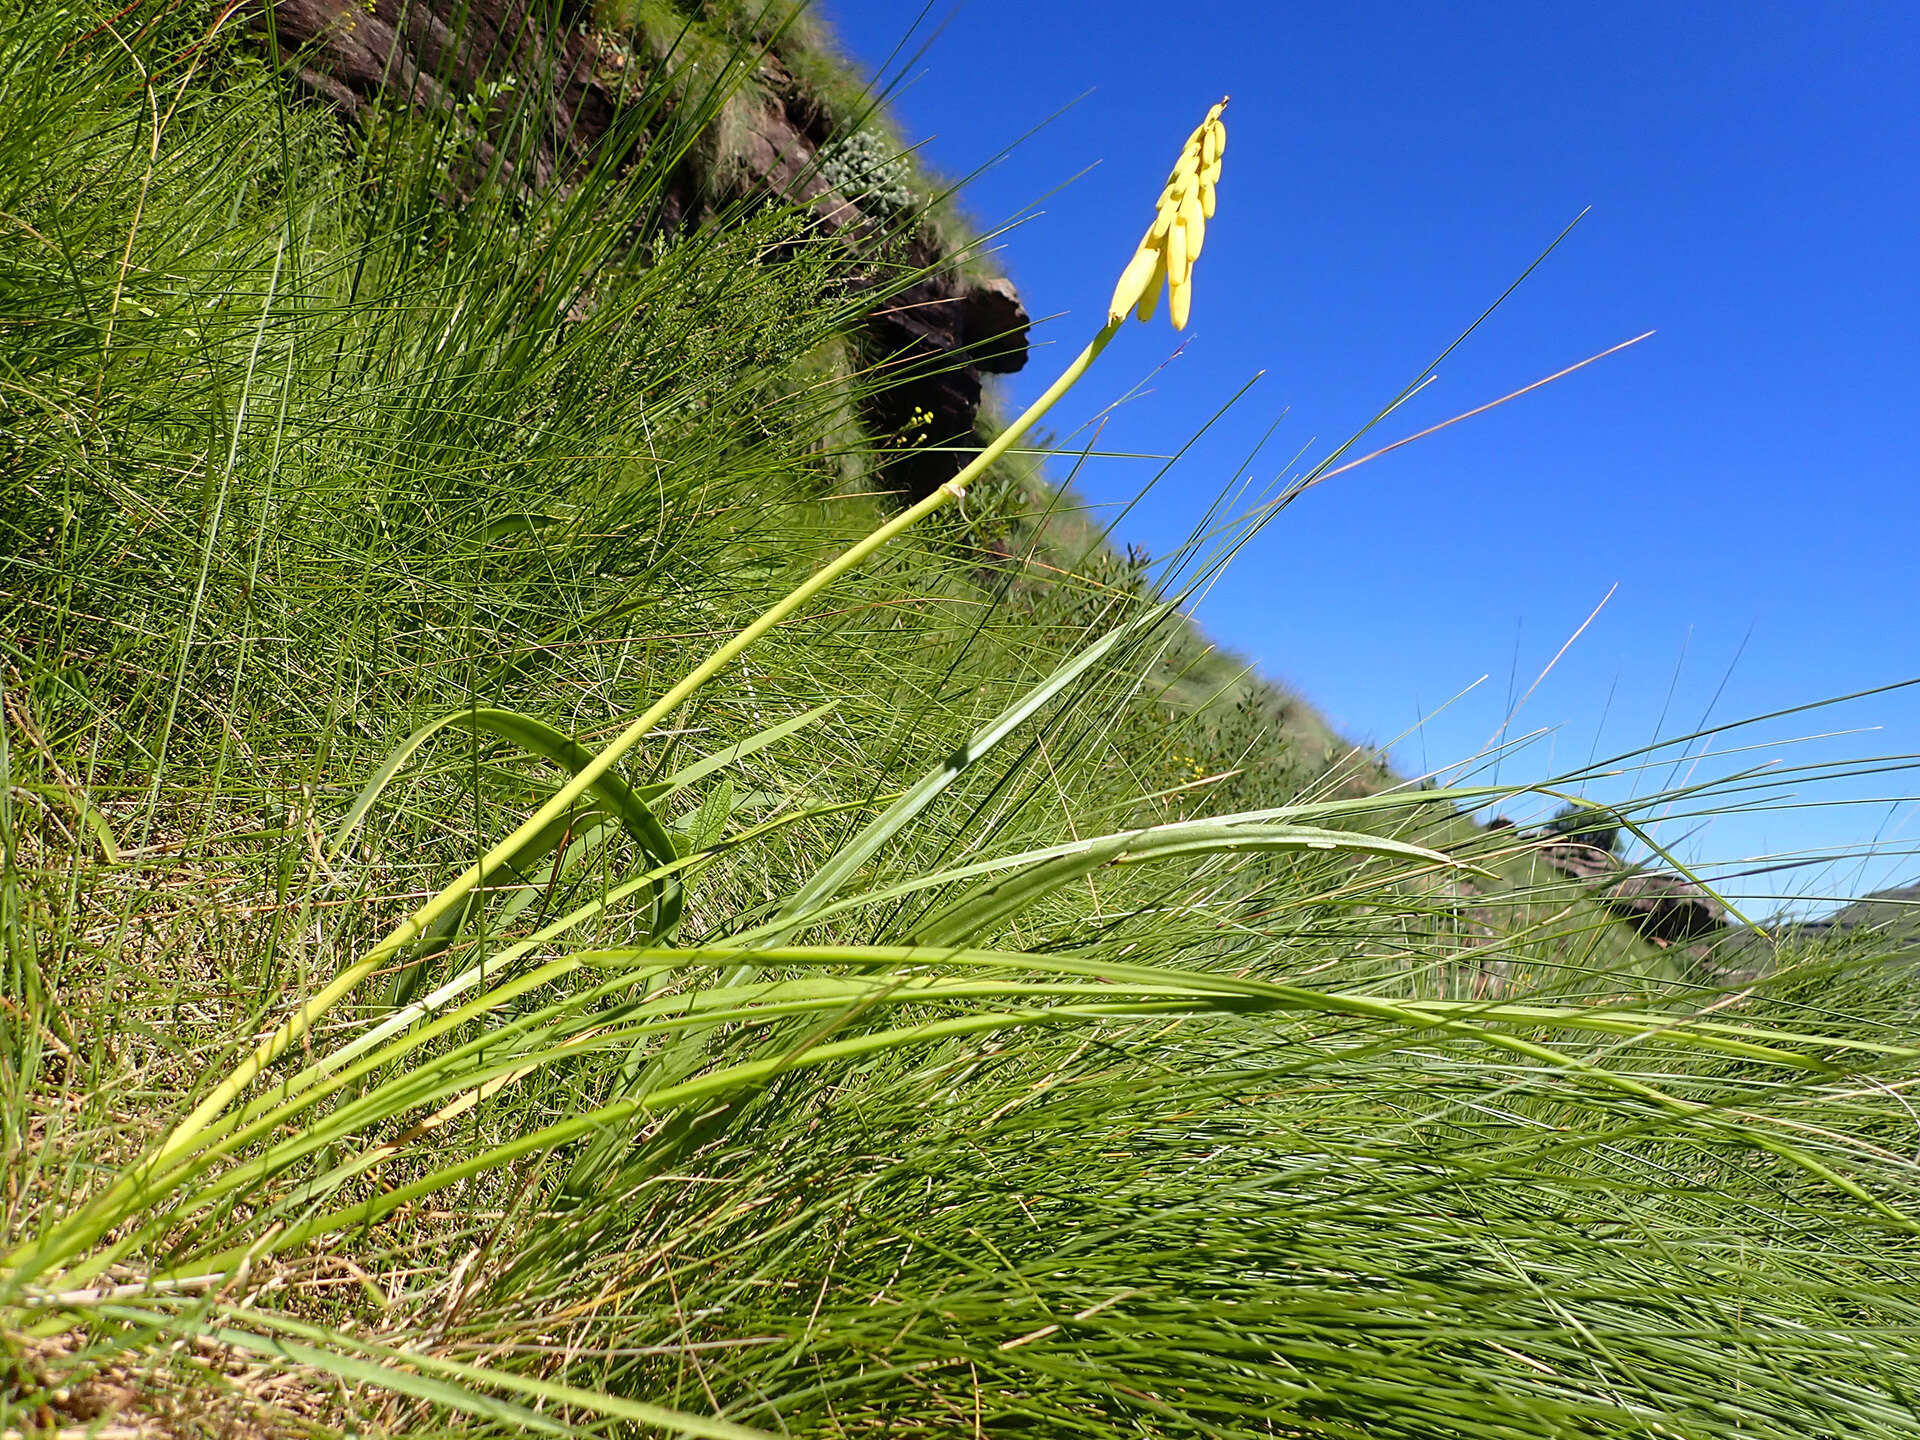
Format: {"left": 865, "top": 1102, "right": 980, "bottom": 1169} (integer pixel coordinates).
{"left": 257, "top": 0, "right": 1027, "bottom": 497}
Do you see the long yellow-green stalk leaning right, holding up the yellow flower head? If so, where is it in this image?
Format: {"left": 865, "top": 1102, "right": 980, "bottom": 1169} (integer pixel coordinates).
{"left": 22, "top": 321, "right": 1119, "bottom": 1263}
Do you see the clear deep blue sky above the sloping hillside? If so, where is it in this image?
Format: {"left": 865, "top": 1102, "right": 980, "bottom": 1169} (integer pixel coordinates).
{"left": 822, "top": 0, "right": 1920, "bottom": 908}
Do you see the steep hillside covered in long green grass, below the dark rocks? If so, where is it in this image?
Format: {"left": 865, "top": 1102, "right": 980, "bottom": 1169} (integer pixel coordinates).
{"left": 11, "top": 6, "right": 1920, "bottom": 1440}
